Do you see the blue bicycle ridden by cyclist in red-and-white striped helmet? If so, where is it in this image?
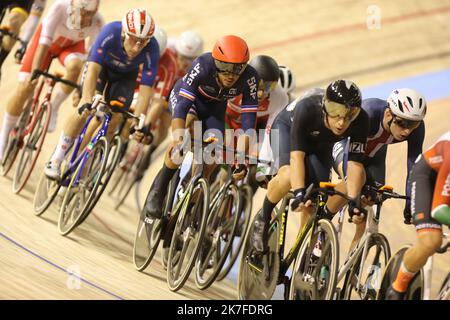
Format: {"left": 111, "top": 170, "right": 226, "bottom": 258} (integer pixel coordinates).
{"left": 34, "top": 95, "right": 145, "bottom": 235}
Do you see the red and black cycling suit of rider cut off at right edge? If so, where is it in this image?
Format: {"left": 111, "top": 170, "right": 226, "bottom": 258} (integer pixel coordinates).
{"left": 411, "top": 131, "right": 450, "bottom": 231}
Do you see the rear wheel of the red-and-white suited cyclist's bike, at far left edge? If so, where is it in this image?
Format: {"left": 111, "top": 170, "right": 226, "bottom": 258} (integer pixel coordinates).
{"left": 1, "top": 99, "right": 32, "bottom": 176}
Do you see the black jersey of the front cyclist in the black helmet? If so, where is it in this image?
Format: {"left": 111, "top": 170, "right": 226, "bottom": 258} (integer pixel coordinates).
{"left": 270, "top": 90, "right": 368, "bottom": 184}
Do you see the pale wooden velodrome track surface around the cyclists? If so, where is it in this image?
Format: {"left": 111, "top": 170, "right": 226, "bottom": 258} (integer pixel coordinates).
{"left": 0, "top": 0, "right": 450, "bottom": 299}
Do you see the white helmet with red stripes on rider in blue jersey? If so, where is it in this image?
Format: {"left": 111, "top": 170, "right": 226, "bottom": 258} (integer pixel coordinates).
{"left": 122, "top": 9, "right": 155, "bottom": 39}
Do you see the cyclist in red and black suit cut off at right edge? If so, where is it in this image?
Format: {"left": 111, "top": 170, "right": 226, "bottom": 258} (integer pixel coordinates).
{"left": 386, "top": 131, "right": 450, "bottom": 300}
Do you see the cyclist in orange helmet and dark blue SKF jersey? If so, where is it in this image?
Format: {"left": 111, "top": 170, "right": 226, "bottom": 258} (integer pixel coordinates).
{"left": 145, "top": 35, "right": 259, "bottom": 219}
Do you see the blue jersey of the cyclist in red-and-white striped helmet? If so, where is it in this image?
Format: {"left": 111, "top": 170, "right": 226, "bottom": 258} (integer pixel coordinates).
{"left": 88, "top": 21, "right": 159, "bottom": 86}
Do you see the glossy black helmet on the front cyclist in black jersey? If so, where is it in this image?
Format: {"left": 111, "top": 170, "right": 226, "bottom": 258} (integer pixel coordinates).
{"left": 325, "top": 80, "right": 361, "bottom": 108}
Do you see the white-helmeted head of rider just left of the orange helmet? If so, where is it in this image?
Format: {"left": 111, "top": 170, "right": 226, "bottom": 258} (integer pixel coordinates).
{"left": 168, "top": 31, "right": 203, "bottom": 75}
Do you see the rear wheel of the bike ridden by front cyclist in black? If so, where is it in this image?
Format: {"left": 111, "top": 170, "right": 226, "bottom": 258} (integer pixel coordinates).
{"left": 238, "top": 208, "right": 281, "bottom": 300}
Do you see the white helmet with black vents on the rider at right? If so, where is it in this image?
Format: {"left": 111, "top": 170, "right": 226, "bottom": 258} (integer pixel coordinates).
{"left": 388, "top": 88, "right": 427, "bottom": 121}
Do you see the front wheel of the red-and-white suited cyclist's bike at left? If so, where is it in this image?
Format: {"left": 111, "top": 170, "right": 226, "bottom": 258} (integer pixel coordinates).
{"left": 12, "top": 101, "right": 51, "bottom": 193}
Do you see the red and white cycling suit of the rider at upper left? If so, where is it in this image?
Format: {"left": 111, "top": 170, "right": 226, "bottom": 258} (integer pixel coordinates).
{"left": 19, "top": 0, "right": 103, "bottom": 81}
